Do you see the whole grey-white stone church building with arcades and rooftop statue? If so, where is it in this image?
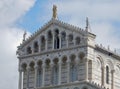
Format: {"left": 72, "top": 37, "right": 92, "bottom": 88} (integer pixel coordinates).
{"left": 17, "top": 6, "right": 120, "bottom": 89}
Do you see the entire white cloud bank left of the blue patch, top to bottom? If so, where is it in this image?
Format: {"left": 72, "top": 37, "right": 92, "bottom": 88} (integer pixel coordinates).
{"left": 0, "top": 0, "right": 35, "bottom": 89}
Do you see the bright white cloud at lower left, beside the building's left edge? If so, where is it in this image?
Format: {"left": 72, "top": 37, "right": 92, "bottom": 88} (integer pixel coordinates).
{"left": 0, "top": 28, "right": 23, "bottom": 89}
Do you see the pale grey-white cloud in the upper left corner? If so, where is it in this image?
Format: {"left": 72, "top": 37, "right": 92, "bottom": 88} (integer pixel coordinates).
{"left": 0, "top": 0, "right": 35, "bottom": 27}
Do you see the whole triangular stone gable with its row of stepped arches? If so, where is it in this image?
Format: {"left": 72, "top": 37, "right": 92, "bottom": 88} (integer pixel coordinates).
{"left": 18, "top": 19, "right": 89, "bottom": 54}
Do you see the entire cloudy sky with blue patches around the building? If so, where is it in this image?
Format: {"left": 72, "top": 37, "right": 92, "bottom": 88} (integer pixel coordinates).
{"left": 0, "top": 0, "right": 120, "bottom": 89}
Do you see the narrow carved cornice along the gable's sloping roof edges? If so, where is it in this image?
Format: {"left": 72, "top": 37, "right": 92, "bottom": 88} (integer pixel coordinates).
{"left": 18, "top": 18, "right": 96, "bottom": 47}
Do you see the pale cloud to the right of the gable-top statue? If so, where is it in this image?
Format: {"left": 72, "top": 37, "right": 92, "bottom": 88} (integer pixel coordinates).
{"left": 47, "top": 0, "right": 120, "bottom": 48}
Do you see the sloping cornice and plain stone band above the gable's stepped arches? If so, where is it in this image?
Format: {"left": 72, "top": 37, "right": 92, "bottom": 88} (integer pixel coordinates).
{"left": 20, "top": 19, "right": 86, "bottom": 47}
